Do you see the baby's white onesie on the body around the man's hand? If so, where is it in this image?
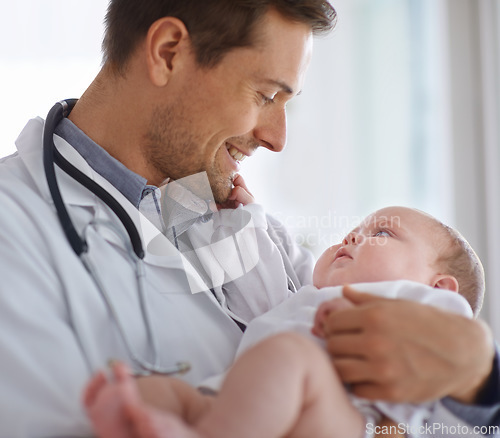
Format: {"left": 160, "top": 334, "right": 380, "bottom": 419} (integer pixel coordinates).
{"left": 237, "top": 280, "right": 472, "bottom": 437}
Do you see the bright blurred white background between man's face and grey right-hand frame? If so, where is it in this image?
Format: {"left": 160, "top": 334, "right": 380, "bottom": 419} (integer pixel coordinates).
{"left": 245, "top": 0, "right": 453, "bottom": 253}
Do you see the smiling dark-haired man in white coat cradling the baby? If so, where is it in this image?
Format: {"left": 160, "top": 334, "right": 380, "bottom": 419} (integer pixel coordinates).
{"left": 0, "top": 0, "right": 500, "bottom": 437}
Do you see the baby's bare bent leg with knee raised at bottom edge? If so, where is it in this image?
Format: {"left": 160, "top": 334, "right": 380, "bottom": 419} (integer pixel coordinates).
{"left": 195, "top": 333, "right": 365, "bottom": 438}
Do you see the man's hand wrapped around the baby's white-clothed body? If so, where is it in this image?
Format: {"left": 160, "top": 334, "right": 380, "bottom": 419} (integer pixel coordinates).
{"left": 323, "top": 286, "right": 494, "bottom": 403}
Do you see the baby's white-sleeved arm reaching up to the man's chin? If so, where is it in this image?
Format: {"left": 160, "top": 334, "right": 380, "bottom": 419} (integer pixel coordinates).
{"left": 212, "top": 175, "right": 291, "bottom": 323}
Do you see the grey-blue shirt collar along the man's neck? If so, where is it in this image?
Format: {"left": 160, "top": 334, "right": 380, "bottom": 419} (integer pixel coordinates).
{"left": 55, "top": 118, "right": 148, "bottom": 208}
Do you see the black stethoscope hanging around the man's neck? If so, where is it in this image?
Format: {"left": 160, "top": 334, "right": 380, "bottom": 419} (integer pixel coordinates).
{"left": 43, "top": 99, "right": 190, "bottom": 375}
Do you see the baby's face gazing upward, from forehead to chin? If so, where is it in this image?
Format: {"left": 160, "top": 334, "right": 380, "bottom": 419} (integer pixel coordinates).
{"left": 313, "top": 207, "right": 440, "bottom": 288}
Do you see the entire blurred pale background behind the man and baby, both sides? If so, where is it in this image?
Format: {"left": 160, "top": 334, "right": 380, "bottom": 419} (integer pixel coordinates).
{"left": 0, "top": 0, "right": 500, "bottom": 339}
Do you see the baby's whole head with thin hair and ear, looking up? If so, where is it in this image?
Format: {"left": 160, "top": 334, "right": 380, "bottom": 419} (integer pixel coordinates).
{"left": 313, "top": 207, "right": 484, "bottom": 315}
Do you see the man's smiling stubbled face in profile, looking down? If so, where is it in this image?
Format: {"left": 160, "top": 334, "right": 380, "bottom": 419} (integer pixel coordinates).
{"left": 146, "top": 10, "right": 312, "bottom": 202}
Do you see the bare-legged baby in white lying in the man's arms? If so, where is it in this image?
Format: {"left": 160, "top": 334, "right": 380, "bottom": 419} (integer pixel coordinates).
{"left": 84, "top": 182, "right": 484, "bottom": 438}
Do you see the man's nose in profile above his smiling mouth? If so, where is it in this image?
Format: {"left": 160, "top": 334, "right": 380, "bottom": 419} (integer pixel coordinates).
{"left": 253, "top": 107, "right": 286, "bottom": 152}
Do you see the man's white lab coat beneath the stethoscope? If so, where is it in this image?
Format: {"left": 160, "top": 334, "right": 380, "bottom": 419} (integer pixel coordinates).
{"left": 0, "top": 118, "right": 311, "bottom": 437}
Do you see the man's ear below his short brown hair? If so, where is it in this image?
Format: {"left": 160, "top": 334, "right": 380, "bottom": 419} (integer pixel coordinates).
{"left": 145, "top": 17, "right": 191, "bottom": 87}
